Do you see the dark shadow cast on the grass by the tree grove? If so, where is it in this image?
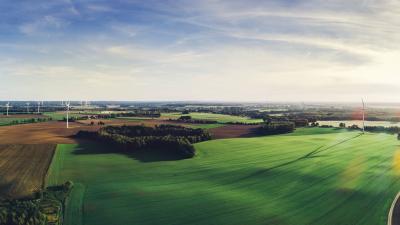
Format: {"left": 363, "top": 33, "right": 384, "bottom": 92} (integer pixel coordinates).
{"left": 73, "top": 139, "right": 185, "bottom": 163}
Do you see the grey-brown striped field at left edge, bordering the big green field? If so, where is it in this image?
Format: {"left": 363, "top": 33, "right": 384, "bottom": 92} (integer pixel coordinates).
{"left": 0, "top": 144, "right": 55, "bottom": 198}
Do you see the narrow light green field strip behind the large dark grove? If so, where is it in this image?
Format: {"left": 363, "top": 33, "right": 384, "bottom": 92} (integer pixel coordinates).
{"left": 161, "top": 113, "right": 263, "bottom": 123}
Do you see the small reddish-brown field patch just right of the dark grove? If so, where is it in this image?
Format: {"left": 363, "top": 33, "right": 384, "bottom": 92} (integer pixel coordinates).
{"left": 209, "top": 125, "right": 259, "bottom": 139}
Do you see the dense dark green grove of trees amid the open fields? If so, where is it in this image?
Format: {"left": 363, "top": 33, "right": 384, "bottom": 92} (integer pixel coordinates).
{"left": 77, "top": 125, "right": 211, "bottom": 158}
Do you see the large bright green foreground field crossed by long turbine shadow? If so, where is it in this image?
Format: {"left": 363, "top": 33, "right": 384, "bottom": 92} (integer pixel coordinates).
{"left": 45, "top": 128, "right": 400, "bottom": 225}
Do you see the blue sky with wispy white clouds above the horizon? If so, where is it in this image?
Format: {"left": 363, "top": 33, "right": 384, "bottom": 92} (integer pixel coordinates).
{"left": 0, "top": 0, "right": 400, "bottom": 102}
